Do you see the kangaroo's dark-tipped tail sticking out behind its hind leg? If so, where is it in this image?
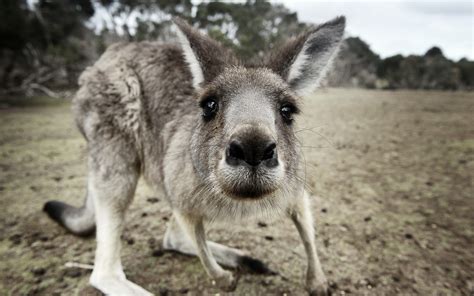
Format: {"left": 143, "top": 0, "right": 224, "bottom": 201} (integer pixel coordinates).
{"left": 43, "top": 194, "right": 95, "bottom": 236}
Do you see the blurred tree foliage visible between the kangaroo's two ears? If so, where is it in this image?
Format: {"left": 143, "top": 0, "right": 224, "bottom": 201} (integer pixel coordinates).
{"left": 193, "top": 0, "right": 307, "bottom": 59}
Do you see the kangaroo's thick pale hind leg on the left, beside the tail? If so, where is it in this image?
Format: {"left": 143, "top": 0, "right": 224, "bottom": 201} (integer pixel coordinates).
{"left": 85, "top": 139, "right": 151, "bottom": 295}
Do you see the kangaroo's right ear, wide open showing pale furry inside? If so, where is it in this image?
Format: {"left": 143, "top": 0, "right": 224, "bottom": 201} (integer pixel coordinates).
{"left": 266, "top": 16, "right": 346, "bottom": 95}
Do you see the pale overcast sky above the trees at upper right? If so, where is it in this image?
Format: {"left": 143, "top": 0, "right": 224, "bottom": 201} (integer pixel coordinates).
{"left": 273, "top": 0, "right": 474, "bottom": 60}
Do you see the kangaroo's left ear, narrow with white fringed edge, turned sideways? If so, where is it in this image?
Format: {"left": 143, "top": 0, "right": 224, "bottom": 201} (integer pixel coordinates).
{"left": 173, "top": 17, "right": 237, "bottom": 88}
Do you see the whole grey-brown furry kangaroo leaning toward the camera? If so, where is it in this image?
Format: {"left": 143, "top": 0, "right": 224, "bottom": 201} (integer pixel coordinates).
{"left": 44, "top": 17, "right": 345, "bottom": 295}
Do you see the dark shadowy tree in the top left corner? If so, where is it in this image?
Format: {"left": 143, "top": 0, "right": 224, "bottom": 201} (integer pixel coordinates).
{"left": 0, "top": 0, "right": 94, "bottom": 90}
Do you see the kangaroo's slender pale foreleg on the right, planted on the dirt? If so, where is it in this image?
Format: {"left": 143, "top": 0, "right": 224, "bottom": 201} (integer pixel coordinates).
{"left": 290, "top": 192, "right": 328, "bottom": 295}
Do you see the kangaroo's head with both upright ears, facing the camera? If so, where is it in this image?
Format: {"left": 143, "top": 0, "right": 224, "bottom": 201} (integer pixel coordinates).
{"left": 175, "top": 17, "right": 345, "bottom": 204}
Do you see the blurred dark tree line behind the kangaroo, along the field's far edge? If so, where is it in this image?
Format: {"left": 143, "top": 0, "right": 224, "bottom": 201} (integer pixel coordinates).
{"left": 0, "top": 0, "right": 474, "bottom": 94}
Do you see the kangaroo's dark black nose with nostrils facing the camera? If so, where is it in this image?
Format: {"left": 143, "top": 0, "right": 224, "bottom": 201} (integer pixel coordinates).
{"left": 226, "top": 138, "right": 278, "bottom": 167}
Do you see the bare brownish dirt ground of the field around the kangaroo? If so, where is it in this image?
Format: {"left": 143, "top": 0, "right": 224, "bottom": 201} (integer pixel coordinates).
{"left": 0, "top": 89, "right": 474, "bottom": 295}
